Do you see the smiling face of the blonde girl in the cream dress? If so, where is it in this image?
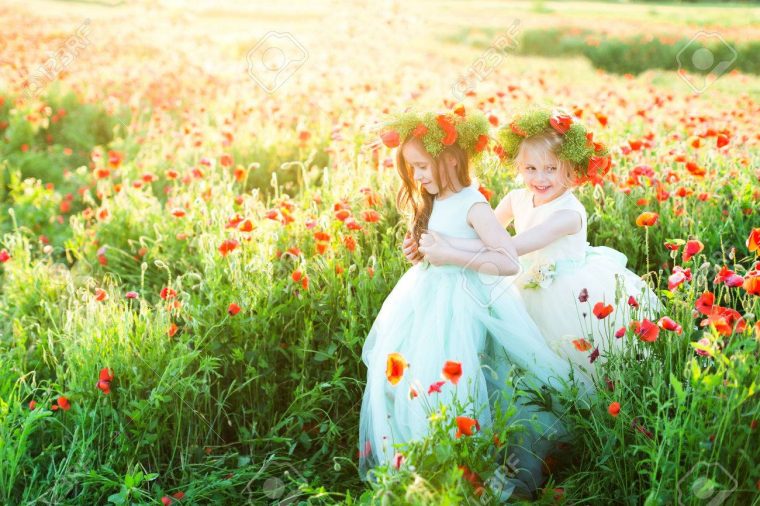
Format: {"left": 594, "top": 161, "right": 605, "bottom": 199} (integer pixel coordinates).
{"left": 517, "top": 146, "right": 568, "bottom": 205}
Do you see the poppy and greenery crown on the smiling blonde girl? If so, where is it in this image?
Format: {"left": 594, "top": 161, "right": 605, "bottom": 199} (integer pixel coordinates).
{"left": 498, "top": 109, "right": 610, "bottom": 184}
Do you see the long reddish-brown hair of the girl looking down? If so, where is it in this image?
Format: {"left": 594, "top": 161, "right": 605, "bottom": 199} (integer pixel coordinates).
{"left": 396, "top": 139, "right": 472, "bottom": 242}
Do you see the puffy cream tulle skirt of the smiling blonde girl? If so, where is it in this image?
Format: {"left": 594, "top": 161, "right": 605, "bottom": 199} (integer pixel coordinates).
{"left": 515, "top": 246, "right": 662, "bottom": 376}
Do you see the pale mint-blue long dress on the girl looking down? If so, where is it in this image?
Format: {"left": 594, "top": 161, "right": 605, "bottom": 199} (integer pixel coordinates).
{"left": 359, "top": 184, "right": 591, "bottom": 498}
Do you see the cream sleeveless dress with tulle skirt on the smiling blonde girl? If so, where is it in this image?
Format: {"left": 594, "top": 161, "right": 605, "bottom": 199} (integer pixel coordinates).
{"left": 510, "top": 188, "right": 661, "bottom": 375}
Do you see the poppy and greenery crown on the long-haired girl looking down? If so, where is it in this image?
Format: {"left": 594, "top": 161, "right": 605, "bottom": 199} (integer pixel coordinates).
{"left": 380, "top": 105, "right": 489, "bottom": 158}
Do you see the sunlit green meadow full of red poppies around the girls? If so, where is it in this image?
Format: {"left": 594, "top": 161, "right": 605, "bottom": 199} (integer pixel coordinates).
{"left": 0, "top": 0, "right": 760, "bottom": 506}
